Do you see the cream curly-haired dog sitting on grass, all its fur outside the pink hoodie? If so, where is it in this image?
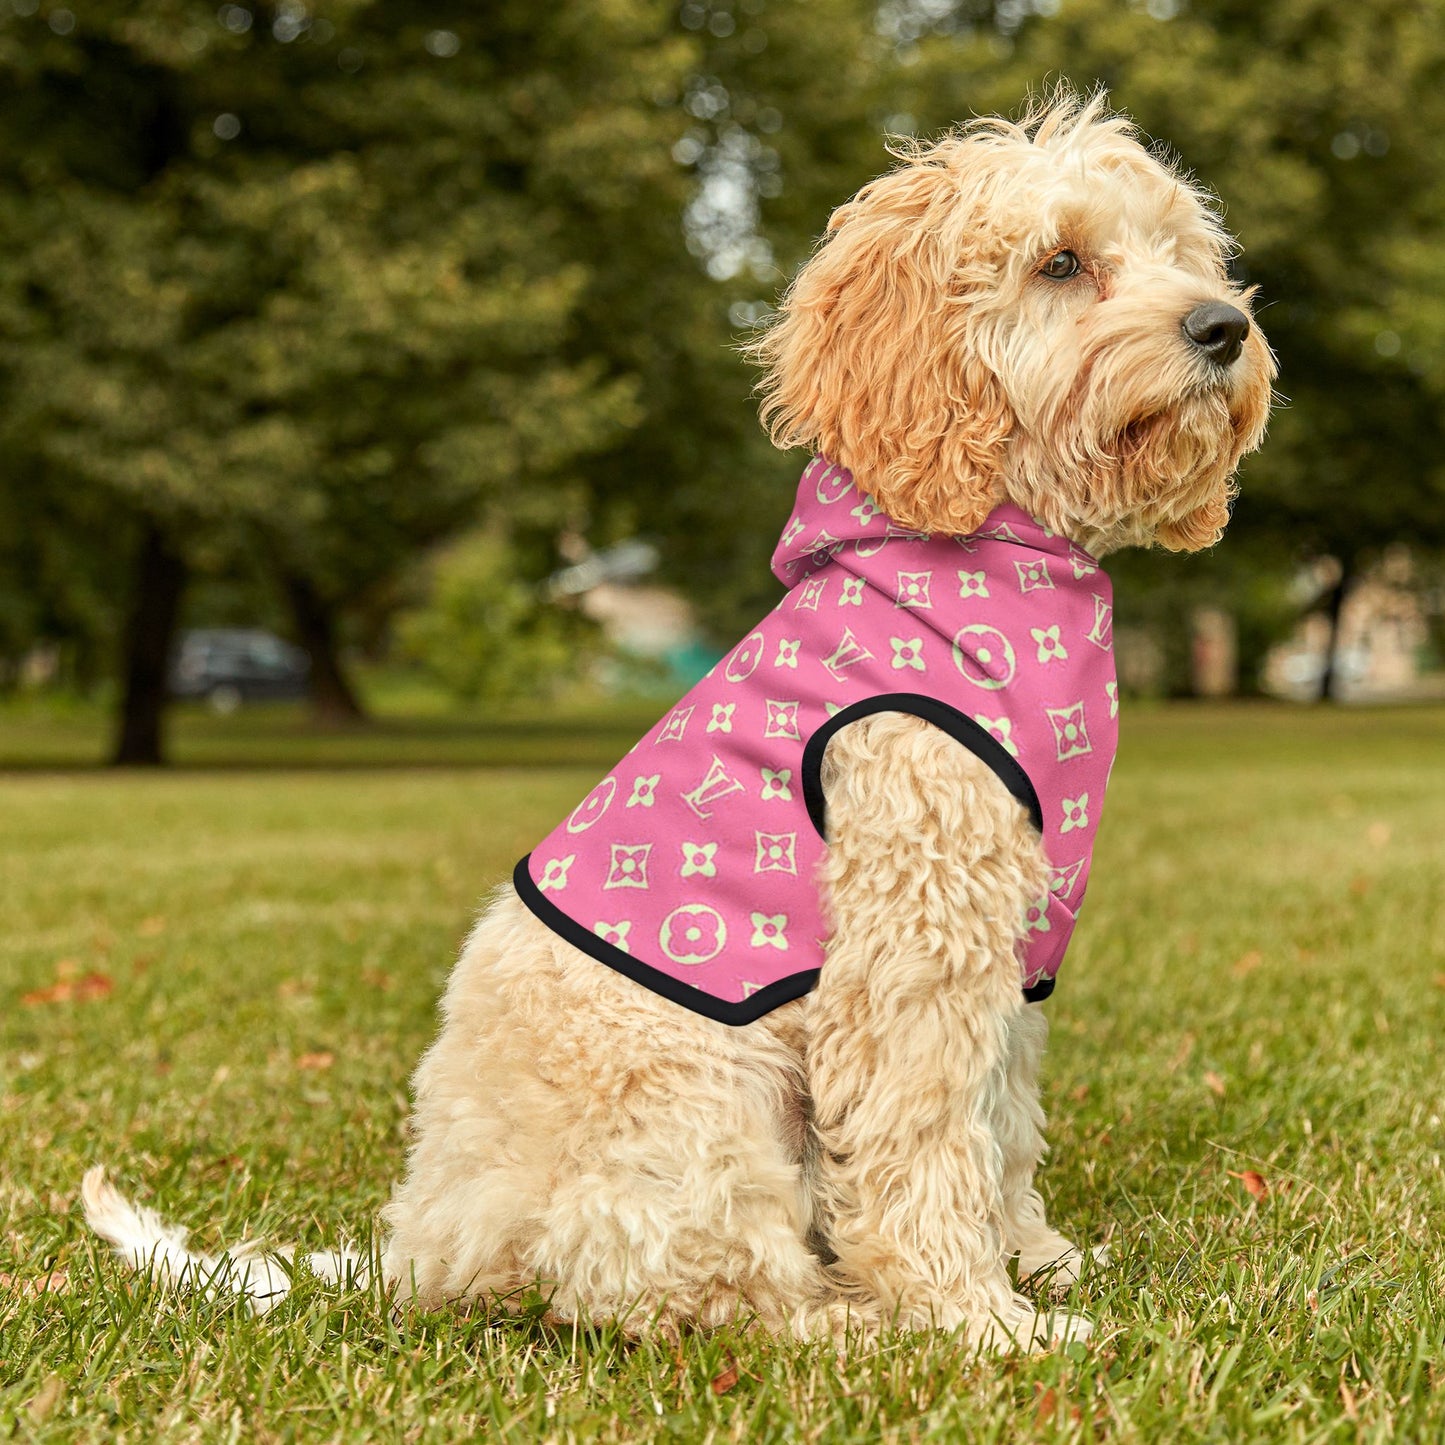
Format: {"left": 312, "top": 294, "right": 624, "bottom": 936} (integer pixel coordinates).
{"left": 85, "top": 95, "right": 1273, "bottom": 1347}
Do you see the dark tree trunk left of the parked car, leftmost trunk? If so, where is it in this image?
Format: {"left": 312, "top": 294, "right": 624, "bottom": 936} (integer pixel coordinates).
{"left": 111, "top": 523, "right": 186, "bottom": 767}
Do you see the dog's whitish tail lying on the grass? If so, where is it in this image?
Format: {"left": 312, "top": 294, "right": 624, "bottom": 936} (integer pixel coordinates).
{"left": 81, "top": 1165, "right": 370, "bottom": 1315}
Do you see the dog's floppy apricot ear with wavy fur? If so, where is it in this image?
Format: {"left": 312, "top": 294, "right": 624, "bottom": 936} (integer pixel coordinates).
{"left": 749, "top": 149, "right": 1013, "bottom": 533}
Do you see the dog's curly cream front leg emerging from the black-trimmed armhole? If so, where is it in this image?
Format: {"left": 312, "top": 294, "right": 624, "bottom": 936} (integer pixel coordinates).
{"left": 808, "top": 714, "right": 1088, "bottom": 1347}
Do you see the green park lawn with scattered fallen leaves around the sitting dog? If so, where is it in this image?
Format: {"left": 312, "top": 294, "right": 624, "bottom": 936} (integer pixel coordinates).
{"left": 0, "top": 707, "right": 1445, "bottom": 1442}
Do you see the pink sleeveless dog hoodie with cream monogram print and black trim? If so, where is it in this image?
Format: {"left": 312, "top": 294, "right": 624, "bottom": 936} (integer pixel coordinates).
{"left": 514, "top": 457, "right": 1118, "bottom": 1025}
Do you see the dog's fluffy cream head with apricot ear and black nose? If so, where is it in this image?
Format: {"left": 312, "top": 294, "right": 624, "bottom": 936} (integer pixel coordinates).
{"left": 751, "top": 92, "right": 1274, "bottom": 552}
